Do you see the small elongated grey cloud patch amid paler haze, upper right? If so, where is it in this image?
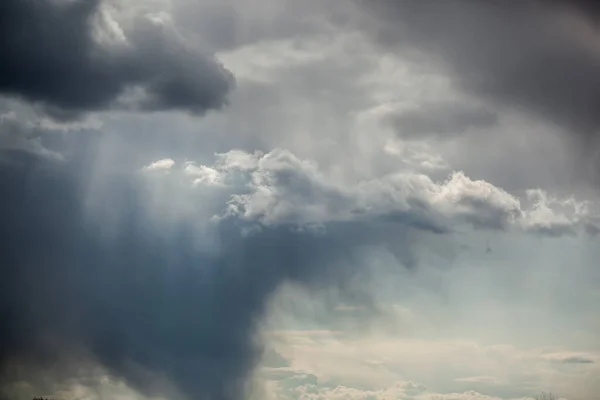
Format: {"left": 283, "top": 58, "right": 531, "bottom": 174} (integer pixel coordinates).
{"left": 389, "top": 103, "right": 498, "bottom": 139}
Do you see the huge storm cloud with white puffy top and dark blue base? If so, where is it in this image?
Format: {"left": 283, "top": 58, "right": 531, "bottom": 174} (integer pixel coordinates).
{"left": 0, "top": 146, "right": 582, "bottom": 399}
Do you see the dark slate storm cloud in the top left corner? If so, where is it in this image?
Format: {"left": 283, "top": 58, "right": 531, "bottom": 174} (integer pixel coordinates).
{"left": 0, "top": 0, "right": 233, "bottom": 118}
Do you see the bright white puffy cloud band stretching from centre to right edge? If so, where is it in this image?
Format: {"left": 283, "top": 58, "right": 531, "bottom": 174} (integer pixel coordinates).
{"left": 198, "top": 150, "right": 594, "bottom": 236}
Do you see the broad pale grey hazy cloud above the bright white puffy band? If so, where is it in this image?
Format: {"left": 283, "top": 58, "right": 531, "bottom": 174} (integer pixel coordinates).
{"left": 204, "top": 17, "right": 589, "bottom": 196}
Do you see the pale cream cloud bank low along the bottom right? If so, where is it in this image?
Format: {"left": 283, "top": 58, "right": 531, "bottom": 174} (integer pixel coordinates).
{"left": 262, "top": 328, "right": 597, "bottom": 400}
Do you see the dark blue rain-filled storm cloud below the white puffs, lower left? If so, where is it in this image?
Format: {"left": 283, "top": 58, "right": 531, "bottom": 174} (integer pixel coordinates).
{"left": 0, "top": 151, "right": 442, "bottom": 399}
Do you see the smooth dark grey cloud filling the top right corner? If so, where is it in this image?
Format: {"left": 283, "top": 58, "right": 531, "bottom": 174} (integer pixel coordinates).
{"left": 360, "top": 0, "right": 600, "bottom": 141}
